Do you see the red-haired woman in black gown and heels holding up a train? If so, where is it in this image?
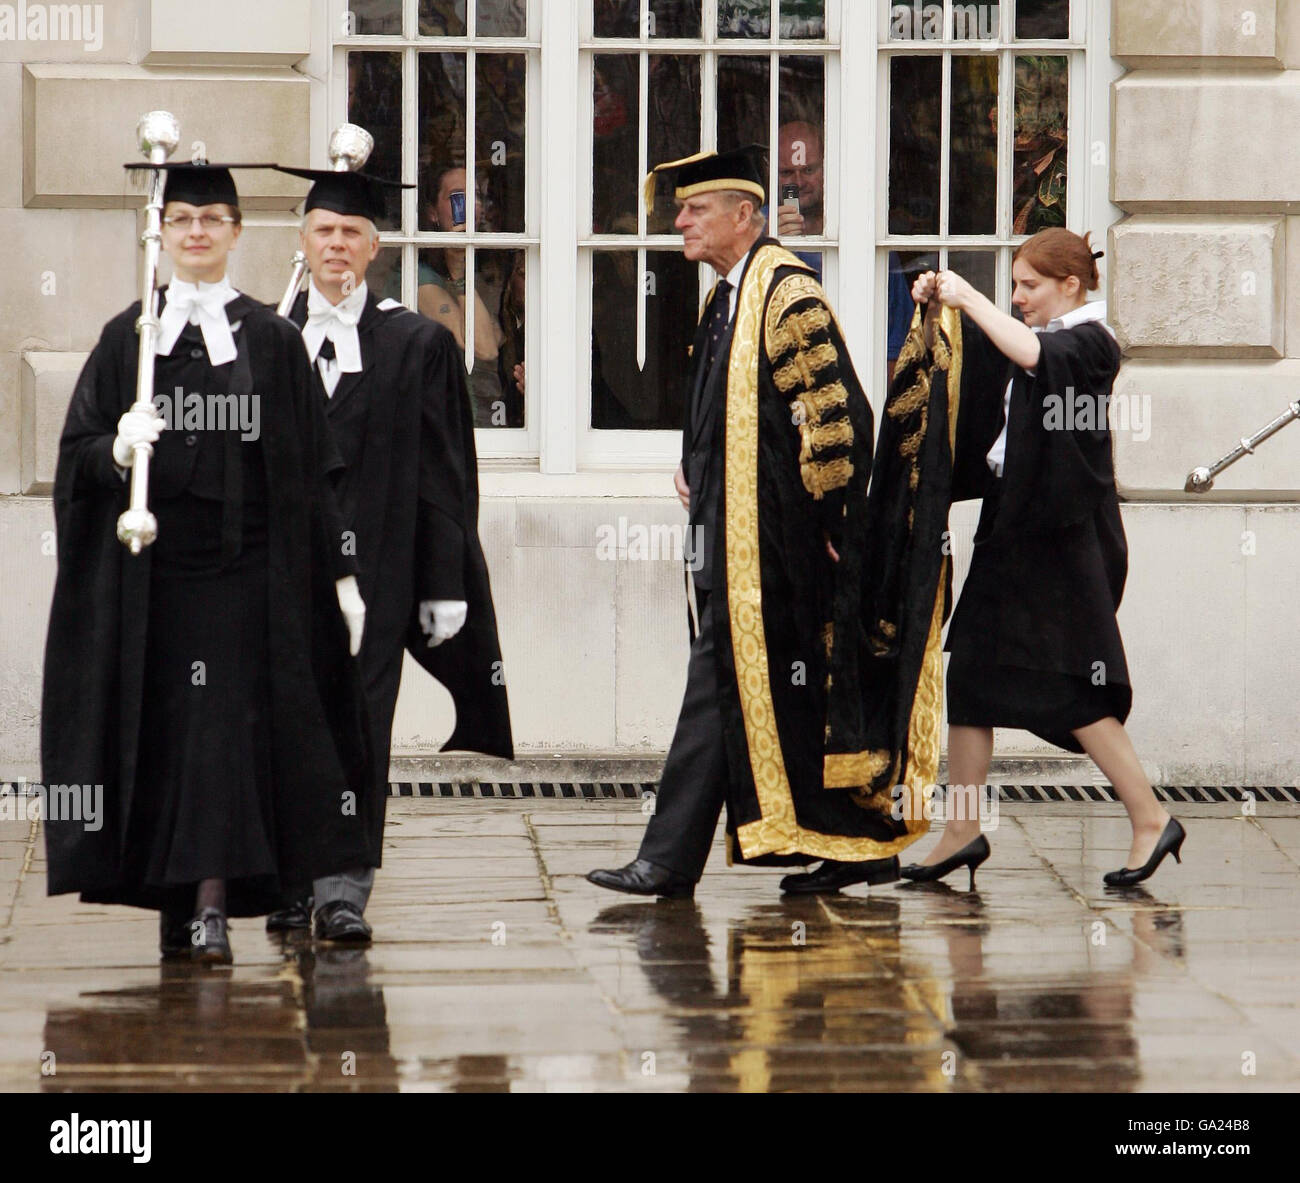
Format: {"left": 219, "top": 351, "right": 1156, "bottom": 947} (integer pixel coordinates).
{"left": 902, "top": 229, "right": 1184, "bottom": 887}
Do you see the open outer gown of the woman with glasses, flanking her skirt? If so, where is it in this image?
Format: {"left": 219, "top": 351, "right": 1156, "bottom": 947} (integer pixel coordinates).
{"left": 42, "top": 298, "right": 372, "bottom": 910}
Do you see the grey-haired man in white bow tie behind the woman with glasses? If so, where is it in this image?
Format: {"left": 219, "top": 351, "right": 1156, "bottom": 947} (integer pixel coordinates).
{"left": 268, "top": 169, "right": 514, "bottom": 943}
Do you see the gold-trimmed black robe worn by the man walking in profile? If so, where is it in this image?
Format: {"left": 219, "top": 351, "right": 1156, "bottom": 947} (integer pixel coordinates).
{"left": 683, "top": 239, "right": 924, "bottom": 865}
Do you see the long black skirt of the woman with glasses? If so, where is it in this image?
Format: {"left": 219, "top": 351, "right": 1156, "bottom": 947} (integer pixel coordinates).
{"left": 100, "top": 495, "right": 281, "bottom": 915}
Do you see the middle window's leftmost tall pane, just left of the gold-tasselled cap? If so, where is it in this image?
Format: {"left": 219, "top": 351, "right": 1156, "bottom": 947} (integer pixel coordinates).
{"left": 592, "top": 53, "right": 642, "bottom": 234}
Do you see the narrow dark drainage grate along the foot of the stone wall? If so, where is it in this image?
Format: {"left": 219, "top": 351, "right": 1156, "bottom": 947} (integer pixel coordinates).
{"left": 389, "top": 781, "right": 1300, "bottom": 805}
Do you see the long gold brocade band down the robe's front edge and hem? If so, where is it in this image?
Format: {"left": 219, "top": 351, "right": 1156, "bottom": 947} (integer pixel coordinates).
{"left": 723, "top": 246, "right": 919, "bottom": 862}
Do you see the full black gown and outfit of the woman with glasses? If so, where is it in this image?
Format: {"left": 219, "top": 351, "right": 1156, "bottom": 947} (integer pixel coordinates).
{"left": 42, "top": 296, "right": 373, "bottom": 915}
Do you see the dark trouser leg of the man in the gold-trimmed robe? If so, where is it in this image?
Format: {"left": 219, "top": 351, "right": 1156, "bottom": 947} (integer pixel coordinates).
{"left": 638, "top": 588, "right": 727, "bottom": 880}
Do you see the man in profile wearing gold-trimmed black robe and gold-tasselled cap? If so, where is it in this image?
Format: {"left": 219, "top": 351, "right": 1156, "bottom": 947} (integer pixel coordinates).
{"left": 588, "top": 151, "right": 939, "bottom": 897}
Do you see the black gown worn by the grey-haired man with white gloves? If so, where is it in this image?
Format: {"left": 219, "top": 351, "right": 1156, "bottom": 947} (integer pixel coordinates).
{"left": 290, "top": 291, "right": 514, "bottom": 866}
